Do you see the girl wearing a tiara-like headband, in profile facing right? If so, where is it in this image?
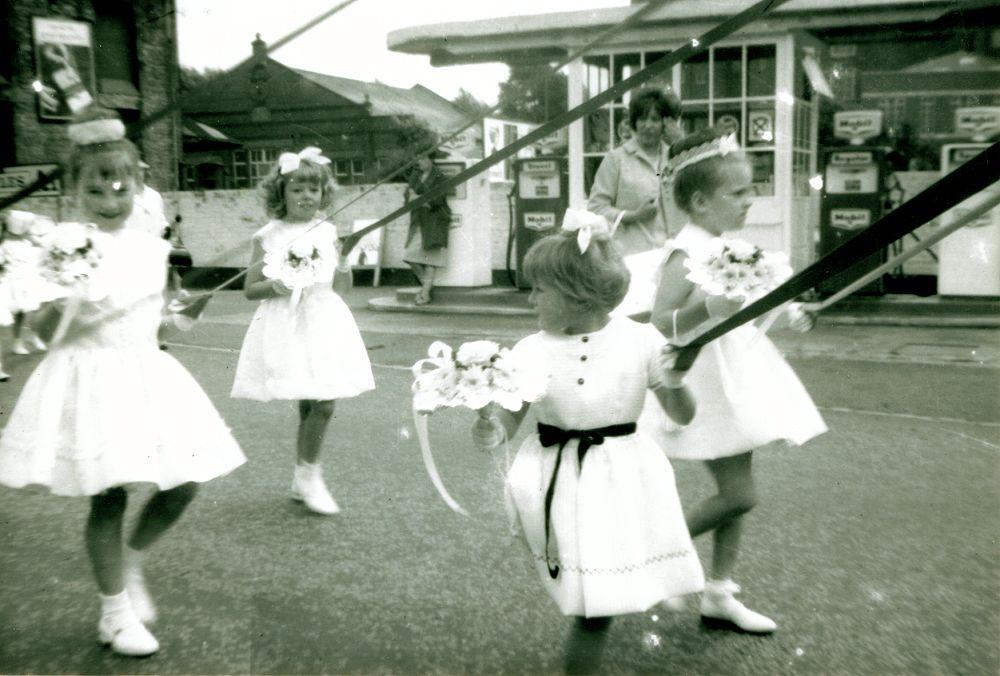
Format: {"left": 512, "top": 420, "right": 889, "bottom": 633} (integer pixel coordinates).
{"left": 639, "top": 130, "right": 826, "bottom": 633}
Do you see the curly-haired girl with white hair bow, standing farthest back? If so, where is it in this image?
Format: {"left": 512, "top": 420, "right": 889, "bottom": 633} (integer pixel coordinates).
{"left": 232, "top": 148, "right": 375, "bottom": 514}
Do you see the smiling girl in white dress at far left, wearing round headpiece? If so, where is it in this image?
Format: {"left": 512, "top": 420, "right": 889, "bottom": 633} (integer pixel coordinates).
{"left": 0, "top": 108, "right": 245, "bottom": 656}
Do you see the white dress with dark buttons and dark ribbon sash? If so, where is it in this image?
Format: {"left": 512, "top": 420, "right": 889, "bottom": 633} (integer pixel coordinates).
{"left": 507, "top": 318, "right": 704, "bottom": 617}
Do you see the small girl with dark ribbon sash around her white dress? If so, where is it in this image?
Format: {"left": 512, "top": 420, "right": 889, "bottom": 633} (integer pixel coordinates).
{"left": 473, "top": 219, "right": 703, "bottom": 672}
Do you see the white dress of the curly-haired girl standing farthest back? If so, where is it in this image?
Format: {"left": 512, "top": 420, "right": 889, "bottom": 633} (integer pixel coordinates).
{"left": 232, "top": 220, "right": 375, "bottom": 401}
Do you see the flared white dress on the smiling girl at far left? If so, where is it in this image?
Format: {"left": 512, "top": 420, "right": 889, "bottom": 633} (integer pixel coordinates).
{"left": 0, "top": 228, "right": 246, "bottom": 495}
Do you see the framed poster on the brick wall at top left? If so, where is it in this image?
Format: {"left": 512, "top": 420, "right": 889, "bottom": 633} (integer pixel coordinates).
{"left": 32, "top": 17, "right": 97, "bottom": 120}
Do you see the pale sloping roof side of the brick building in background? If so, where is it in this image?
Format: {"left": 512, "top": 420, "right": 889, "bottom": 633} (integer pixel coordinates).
{"left": 292, "top": 68, "right": 466, "bottom": 132}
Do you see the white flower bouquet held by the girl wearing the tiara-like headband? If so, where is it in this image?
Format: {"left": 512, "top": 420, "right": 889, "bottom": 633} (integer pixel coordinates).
{"left": 684, "top": 237, "right": 792, "bottom": 303}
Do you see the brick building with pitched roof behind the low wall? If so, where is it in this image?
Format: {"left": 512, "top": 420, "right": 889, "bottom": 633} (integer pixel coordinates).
{"left": 182, "top": 37, "right": 466, "bottom": 188}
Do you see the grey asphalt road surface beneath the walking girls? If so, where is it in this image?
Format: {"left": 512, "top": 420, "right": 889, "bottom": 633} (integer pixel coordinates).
{"left": 0, "top": 288, "right": 1000, "bottom": 674}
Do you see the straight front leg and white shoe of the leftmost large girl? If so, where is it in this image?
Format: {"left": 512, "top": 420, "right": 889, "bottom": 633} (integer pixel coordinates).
{"left": 85, "top": 488, "right": 160, "bottom": 657}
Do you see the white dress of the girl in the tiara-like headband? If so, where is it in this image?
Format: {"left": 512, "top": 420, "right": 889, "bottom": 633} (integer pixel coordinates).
{"left": 639, "top": 224, "right": 827, "bottom": 460}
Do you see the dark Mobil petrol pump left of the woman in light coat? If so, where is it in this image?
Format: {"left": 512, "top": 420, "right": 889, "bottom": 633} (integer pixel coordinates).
{"left": 514, "top": 157, "right": 569, "bottom": 289}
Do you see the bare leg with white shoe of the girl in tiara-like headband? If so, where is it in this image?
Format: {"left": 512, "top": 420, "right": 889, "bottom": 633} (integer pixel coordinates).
{"left": 687, "top": 452, "right": 777, "bottom": 634}
